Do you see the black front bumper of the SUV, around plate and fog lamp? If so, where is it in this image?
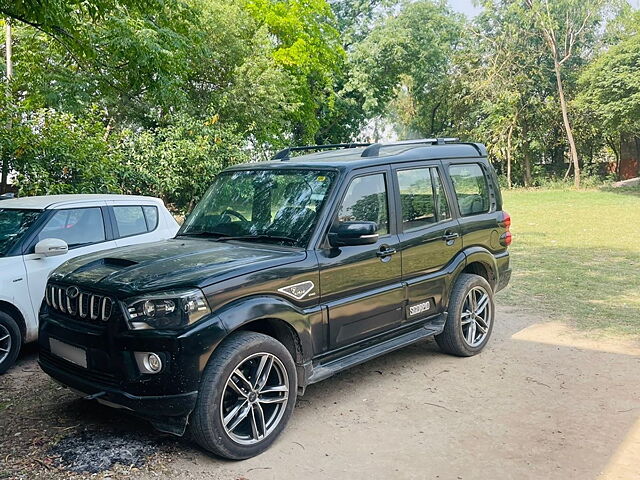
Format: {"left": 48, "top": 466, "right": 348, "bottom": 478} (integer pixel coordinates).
{"left": 38, "top": 307, "right": 225, "bottom": 435}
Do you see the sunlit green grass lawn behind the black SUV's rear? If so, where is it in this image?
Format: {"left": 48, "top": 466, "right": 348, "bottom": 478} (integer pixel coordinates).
{"left": 498, "top": 189, "right": 640, "bottom": 335}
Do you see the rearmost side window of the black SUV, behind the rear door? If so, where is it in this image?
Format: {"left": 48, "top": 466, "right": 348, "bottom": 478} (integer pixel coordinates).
{"left": 449, "top": 163, "right": 490, "bottom": 216}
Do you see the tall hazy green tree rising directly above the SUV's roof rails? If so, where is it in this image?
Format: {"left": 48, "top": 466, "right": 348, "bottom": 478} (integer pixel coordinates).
{"left": 347, "top": 0, "right": 463, "bottom": 135}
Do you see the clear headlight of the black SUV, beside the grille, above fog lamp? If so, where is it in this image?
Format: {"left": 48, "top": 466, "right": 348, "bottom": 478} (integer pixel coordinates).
{"left": 125, "top": 289, "right": 211, "bottom": 330}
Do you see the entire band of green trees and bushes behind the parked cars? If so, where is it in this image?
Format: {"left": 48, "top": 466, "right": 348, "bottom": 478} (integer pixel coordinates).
{"left": 0, "top": 0, "right": 640, "bottom": 211}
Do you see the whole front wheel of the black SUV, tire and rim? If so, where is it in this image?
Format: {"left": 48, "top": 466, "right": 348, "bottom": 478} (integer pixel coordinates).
{"left": 190, "top": 331, "right": 298, "bottom": 460}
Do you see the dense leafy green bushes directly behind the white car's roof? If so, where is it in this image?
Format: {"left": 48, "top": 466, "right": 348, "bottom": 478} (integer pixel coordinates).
{"left": 5, "top": 103, "right": 249, "bottom": 213}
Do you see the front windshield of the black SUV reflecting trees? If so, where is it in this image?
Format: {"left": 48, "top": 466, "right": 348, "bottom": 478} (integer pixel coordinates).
{"left": 178, "top": 169, "right": 335, "bottom": 247}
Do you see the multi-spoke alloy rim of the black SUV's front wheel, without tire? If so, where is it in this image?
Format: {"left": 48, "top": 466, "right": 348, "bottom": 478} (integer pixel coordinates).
{"left": 220, "top": 352, "right": 289, "bottom": 445}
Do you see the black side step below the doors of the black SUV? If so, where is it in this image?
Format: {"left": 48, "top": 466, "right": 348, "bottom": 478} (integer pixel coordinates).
{"left": 307, "top": 325, "right": 442, "bottom": 385}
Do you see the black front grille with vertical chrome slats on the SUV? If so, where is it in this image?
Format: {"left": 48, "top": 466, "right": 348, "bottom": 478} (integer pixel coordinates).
{"left": 45, "top": 284, "right": 114, "bottom": 322}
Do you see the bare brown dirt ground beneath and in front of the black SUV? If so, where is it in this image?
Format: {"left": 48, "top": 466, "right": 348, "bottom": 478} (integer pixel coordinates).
{"left": 0, "top": 307, "right": 640, "bottom": 480}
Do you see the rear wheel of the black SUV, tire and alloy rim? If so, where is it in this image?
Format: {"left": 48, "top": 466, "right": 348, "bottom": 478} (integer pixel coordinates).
{"left": 435, "top": 273, "right": 495, "bottom": 357}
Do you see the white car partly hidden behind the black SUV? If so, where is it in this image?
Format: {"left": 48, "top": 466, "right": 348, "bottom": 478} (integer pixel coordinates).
{"left": 0, "top": 195, "right": 179, "bottom": 374}
